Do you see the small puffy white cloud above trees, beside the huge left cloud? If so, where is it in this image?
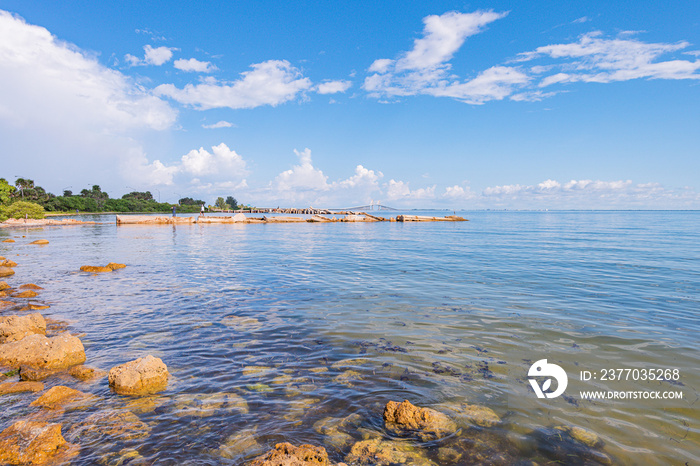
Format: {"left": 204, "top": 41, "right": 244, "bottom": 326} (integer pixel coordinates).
{"left": 180, "top": 142, "right": 248, "bottom": 177}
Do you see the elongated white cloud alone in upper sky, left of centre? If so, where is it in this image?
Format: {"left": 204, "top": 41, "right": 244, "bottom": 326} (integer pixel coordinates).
{"left": 159, "top": 60, "right": 312, "bottom": 110}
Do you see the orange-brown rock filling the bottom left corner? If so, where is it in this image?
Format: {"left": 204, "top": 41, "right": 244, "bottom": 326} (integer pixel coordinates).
{"left": 0, "top": 421, "right": 78, "bottom": 464}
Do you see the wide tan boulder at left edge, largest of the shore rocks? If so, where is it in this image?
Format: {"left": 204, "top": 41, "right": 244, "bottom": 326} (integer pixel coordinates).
{"left": 0, "top": 332, "right": 85, "bottom": 369}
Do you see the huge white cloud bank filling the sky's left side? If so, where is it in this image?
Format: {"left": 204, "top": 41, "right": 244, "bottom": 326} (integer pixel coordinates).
{"left": 0, "top": 11, "right": 177, "bottom": 189}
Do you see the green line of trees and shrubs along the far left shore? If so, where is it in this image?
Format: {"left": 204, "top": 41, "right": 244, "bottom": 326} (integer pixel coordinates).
{"left": 0, "top": 178, "right": 243, "bottom": 221}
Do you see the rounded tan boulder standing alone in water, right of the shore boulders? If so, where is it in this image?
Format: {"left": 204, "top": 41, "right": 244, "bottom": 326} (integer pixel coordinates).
{"left": 109, "top": 355, "right": 169, "bottom": 395}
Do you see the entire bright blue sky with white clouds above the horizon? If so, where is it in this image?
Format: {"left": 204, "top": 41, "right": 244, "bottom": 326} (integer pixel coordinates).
{"left": 0, "top": 0, "right": 700, "bottom": 209}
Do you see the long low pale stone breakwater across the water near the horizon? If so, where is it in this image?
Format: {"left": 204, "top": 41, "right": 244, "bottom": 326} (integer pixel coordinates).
{"left": 117, "top": 212, "right": 467, "bottom": 225}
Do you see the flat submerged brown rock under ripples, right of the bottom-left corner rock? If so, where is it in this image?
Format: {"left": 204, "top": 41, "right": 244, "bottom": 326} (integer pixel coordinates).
{"left": 66, "top": 411, "right": 151, "bottom": 446}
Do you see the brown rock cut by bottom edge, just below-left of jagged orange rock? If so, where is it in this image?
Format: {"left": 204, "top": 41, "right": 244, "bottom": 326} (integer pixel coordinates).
{"left": 345, "top": 438, "right": 435, "bottom": 466}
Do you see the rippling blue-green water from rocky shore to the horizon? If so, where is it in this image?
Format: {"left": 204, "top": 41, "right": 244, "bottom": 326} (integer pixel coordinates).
{"left": 0, "top": 212, "right": 700, "bottom": 464}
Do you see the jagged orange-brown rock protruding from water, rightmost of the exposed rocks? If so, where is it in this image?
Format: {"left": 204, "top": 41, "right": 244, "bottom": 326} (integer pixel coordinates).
{"left": 384, "top": 400, "right": 457, "bottom": 441}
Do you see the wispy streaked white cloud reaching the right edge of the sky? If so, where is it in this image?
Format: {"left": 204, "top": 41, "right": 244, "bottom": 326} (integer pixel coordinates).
{"left": 518, "top": 32, "right": 700, "bottom": 87}
